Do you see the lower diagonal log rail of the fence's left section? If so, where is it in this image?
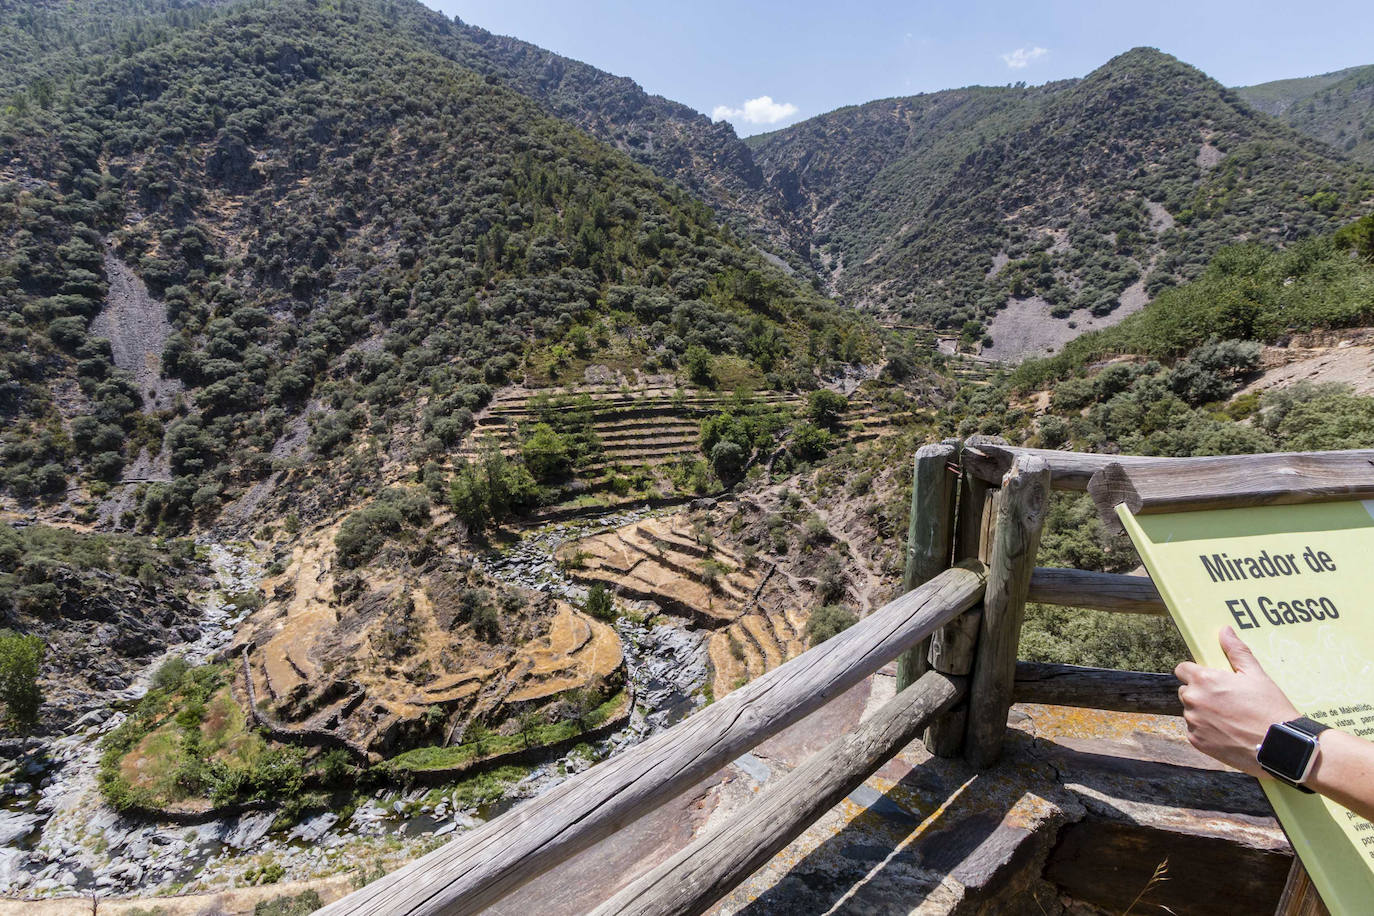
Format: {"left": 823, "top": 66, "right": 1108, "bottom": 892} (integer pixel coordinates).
{"left": 592, "top": 672, "right": 966, "bottom": 916}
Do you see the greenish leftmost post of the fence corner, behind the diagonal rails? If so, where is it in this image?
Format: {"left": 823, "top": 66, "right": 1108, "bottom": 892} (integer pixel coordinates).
{"left": 897, "top": 439, "right": 959, "bottom": 691}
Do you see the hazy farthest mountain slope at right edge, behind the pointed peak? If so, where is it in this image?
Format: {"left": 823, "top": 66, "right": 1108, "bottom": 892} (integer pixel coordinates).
{"left": 1235, "top": 66, "right": 1374, "bottom": 165}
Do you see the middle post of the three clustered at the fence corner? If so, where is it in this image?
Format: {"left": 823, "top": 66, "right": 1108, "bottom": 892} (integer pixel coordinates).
{"left": 923, "top": 435, "right": 1006, "bottom": 757}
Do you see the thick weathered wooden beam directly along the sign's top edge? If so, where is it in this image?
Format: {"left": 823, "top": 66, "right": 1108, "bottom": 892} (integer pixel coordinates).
{"left": 1088, "top": 449, "right": 1374, "bottom": 527}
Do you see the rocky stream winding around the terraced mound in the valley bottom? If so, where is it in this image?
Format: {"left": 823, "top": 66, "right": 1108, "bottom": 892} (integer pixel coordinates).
{"left": 0, "top": 511, "right": 706, "bottom": 895}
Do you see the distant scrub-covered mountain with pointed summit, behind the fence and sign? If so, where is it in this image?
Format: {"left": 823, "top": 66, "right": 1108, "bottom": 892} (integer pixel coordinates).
{"left": 749, "top": 48, "right": 1374, "bottom": 346}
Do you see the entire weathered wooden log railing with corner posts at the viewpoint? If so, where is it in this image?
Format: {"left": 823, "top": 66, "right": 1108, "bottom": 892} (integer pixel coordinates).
{"left": 323, "top": 437, "right": 1374, "bottom": 916}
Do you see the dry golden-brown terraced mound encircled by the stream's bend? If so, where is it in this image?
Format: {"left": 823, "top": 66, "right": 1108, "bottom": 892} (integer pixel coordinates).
{"left": 239, "top": 516, "right": 622, "bottom": 755}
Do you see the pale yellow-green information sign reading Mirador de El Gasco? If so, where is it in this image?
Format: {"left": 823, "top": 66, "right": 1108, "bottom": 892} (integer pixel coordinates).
{"left": 1117, "top": 501, "right": 1374, "bottom": 915}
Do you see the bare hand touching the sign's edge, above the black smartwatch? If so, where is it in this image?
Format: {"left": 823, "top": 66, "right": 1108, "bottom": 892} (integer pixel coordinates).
{"left": 1173, "top": 626, "right": 1300, "bottom": 776}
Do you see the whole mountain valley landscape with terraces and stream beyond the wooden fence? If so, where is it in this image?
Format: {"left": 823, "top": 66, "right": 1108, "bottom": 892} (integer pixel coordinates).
{"left": 0, "top": 0, "right": 1374, "bottom": 916}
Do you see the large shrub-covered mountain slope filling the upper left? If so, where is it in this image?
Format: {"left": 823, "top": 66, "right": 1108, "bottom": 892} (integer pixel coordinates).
{"left": 0, "top": 0, "right": 867, "bottom": 526}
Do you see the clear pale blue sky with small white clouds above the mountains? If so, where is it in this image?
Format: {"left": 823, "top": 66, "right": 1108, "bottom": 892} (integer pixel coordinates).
{"left": 425, "top": 0, "right": 1374, "bottom": 136}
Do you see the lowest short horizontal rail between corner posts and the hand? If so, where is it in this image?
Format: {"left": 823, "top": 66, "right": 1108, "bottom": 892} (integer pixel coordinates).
{"left": 1011, "top": 662, "right": 1183, "bottom": 715}
